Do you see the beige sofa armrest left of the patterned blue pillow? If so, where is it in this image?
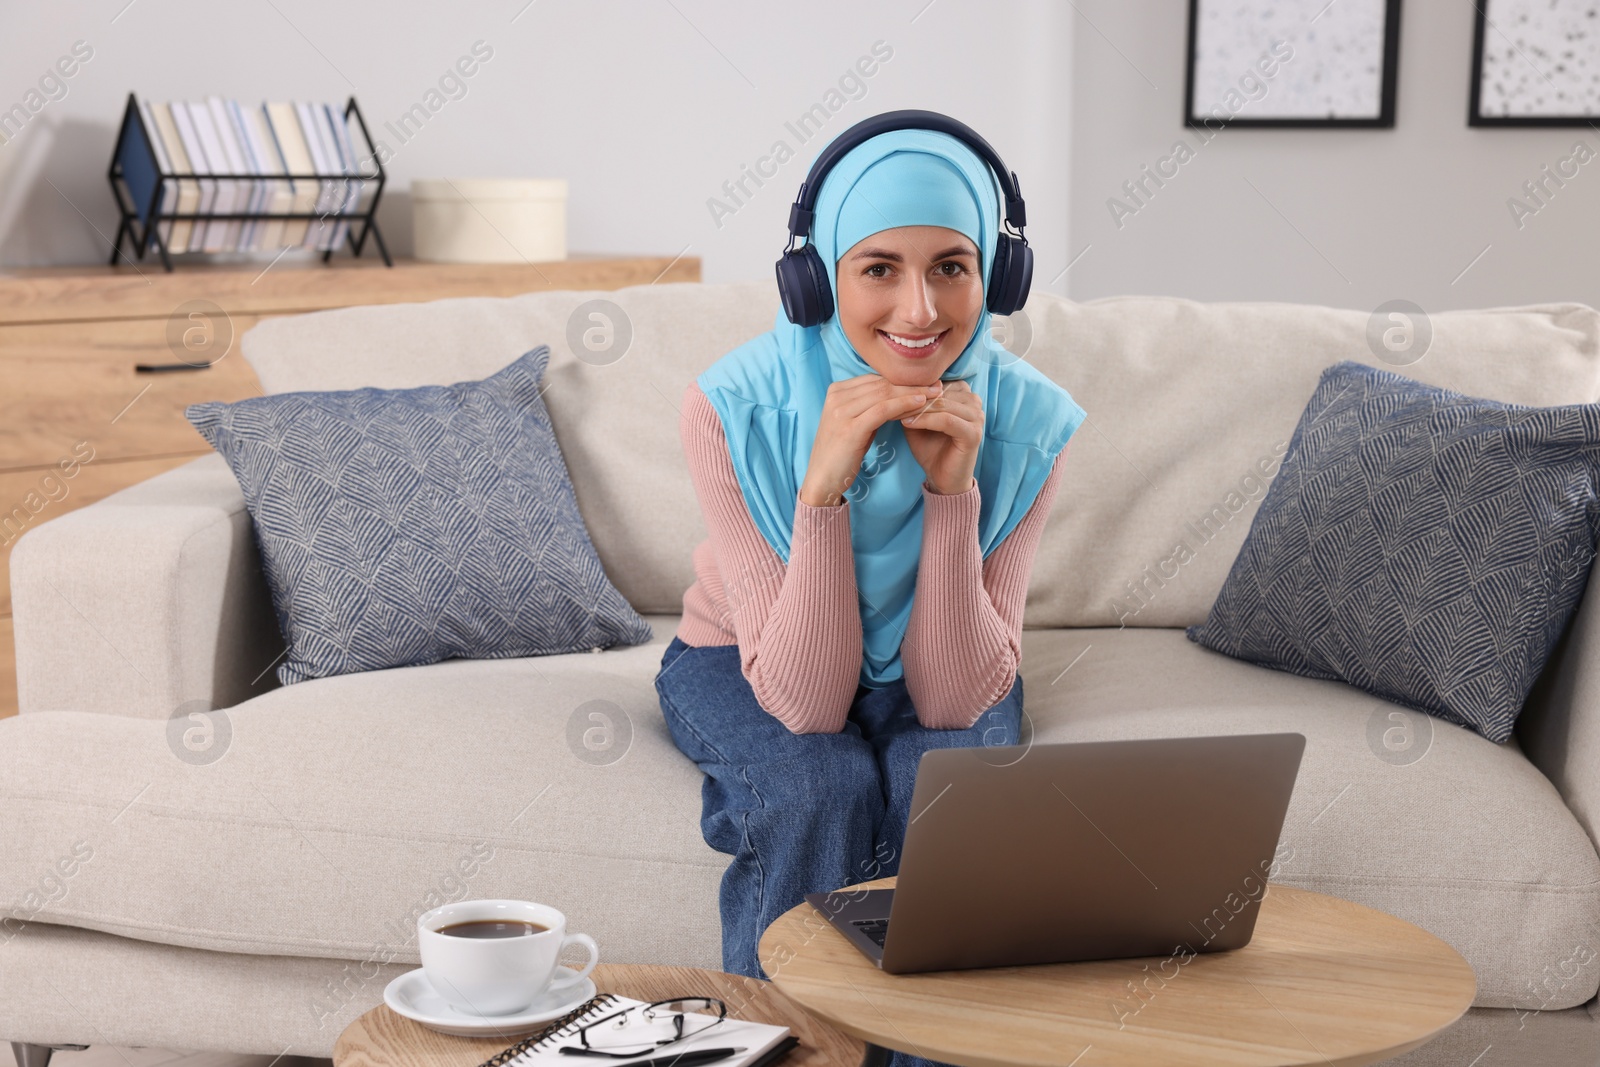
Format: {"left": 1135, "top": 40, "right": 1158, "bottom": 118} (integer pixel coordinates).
{"left": 11, "top": 453, "right": 283, "bottom": 718}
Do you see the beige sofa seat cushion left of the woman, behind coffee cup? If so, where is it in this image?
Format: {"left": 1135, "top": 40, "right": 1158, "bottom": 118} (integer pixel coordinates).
{"left": 0, "top": 617, "right": 726, "bottom": 966}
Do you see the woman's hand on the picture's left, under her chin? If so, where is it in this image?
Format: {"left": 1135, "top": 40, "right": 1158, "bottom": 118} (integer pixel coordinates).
{"left": 800, "top": 374, "right": 934, "bottom": 507}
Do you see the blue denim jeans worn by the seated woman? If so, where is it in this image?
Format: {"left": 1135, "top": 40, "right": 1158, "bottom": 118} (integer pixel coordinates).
{"left": 656, "top": 637, "right": 1022, "bottom": 1067}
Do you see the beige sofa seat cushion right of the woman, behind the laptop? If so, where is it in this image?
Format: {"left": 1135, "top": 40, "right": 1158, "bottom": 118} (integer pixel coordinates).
{"left": 1022, "top": 627, "right": 1600, "bottom": 1009}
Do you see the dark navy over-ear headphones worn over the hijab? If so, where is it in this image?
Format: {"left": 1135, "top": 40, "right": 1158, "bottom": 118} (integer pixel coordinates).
{"left": 778, "top": 110, "right": 1034, "bottom": 326}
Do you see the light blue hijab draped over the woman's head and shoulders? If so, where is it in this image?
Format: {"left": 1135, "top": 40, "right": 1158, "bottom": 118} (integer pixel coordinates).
{"left": 696, "top": 130, "right": 1085, "bottom": 688}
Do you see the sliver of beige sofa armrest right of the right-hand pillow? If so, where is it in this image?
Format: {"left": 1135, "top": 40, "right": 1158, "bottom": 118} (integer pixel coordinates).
{"left": 1515, "top": 571, "right": 1600, "bottom": 848}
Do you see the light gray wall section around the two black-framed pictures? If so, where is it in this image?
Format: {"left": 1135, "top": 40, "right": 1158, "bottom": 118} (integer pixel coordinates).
{"left": 1069, "top": 0, "right": 1600, "bottom": 310}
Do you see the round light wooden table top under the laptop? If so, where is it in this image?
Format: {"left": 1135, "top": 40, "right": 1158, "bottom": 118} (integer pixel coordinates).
{"left": 760, "top": 878, "right": 1477, "bottom": 1067}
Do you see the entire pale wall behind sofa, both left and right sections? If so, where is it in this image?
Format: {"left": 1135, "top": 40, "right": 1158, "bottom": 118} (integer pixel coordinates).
{"left": 12, "top": 0, "right": 1600, "bottom": 310}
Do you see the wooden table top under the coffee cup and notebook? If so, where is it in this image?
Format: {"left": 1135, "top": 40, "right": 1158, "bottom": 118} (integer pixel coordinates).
{"left": 333, "top": 963, "right": 864, "bottom": 1067}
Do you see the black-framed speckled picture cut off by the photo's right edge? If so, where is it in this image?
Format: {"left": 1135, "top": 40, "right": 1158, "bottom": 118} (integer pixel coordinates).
{"left": 1467, "top": 0, "right": 1600, "bottom": 126}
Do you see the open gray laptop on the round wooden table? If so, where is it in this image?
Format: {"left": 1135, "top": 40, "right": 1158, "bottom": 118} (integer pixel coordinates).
{"left": 805, "top": 733, "right": 1306, "bottom": 974}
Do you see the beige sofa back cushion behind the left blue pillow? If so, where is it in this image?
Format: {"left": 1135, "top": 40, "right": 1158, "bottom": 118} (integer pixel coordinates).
{"left": 240, "top": 283, "right": 778, "bottom": 614}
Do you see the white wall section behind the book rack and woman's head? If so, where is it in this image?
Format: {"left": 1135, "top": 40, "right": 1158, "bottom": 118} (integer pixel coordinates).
{"left": 0, "top": 0, "right": 1074, "bottom": 293}
